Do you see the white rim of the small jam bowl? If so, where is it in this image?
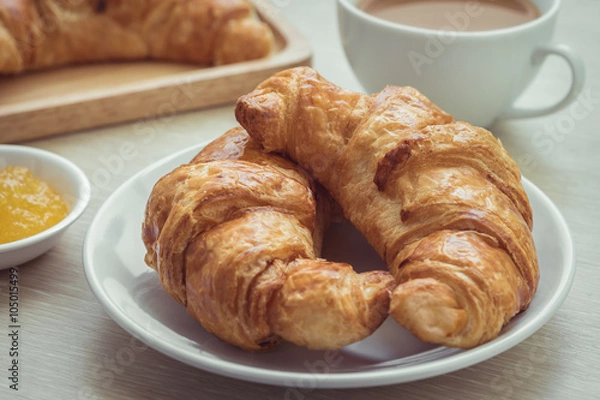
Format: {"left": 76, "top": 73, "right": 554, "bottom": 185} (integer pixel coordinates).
{"left": 0, "top": 144, "right": 91, "bottom": 254}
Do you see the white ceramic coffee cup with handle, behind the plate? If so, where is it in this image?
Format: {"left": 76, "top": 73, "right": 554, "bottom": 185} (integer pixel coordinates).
{"left": 338, "top": 0, "right": 585, "bottom": 127}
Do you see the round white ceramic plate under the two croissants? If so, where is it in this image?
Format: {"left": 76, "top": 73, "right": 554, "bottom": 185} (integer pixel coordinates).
{"left": 84, "top": 142, "right": 575, "bottom": 388}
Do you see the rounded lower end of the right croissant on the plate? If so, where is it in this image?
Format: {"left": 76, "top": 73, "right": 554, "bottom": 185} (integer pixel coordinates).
{"left": 390, "top": 230, "right": 529, "bottom": 347}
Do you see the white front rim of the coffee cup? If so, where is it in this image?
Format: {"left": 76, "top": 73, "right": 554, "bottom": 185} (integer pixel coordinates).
{"left": 337, "top": 0, "right": 561, "bottom": 38}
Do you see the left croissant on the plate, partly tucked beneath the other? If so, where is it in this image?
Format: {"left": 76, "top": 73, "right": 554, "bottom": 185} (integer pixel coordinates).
{"left": 142, "top": 127, "right": 395, "bottom": 351}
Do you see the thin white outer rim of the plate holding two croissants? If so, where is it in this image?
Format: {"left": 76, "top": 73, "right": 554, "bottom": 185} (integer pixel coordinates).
{"left": 82, "top": 140, "right": 576, "bottom": 389}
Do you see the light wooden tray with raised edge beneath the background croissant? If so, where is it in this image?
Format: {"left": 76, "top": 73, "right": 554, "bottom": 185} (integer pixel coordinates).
{"left": 0, "top": 1, "right": 312, "bottom": 143}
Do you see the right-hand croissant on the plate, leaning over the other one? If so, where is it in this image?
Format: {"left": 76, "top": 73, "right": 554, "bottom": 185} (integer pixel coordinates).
{"left": 236, "top": 68, "right": 539, "bottom": 348}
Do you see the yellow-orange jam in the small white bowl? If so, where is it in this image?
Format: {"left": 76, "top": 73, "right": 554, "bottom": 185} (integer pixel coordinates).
{"left": 0, "top": 167, "right": 69, "bottom": 244}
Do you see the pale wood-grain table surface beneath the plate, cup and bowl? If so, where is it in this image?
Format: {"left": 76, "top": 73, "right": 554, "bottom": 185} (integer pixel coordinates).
{"left": 0, "top": 0, "right": 600, "bottom": 400}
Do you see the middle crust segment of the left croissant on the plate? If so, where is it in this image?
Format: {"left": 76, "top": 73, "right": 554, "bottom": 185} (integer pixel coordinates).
{"left": 186, "top": 209, "right": 312, "bottom": 350}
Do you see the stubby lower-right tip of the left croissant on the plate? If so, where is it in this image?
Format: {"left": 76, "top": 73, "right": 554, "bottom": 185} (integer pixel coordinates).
{"left": 269, "top": 259, "right": 393, "bottom": 349}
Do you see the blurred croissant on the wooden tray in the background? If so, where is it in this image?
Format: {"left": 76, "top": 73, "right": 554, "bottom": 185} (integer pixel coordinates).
{"left": 0, "top": 0, "right": 274, "bottom": 74}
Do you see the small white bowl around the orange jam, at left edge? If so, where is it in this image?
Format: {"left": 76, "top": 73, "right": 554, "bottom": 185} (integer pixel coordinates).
{"left": 0, "top": 145, "right": 91, "bottom": 270}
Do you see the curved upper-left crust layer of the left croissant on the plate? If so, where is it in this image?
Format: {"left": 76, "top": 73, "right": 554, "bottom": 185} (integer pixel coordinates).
{"left": 143, "top": 160, "right": 315, "bottom": 304}
